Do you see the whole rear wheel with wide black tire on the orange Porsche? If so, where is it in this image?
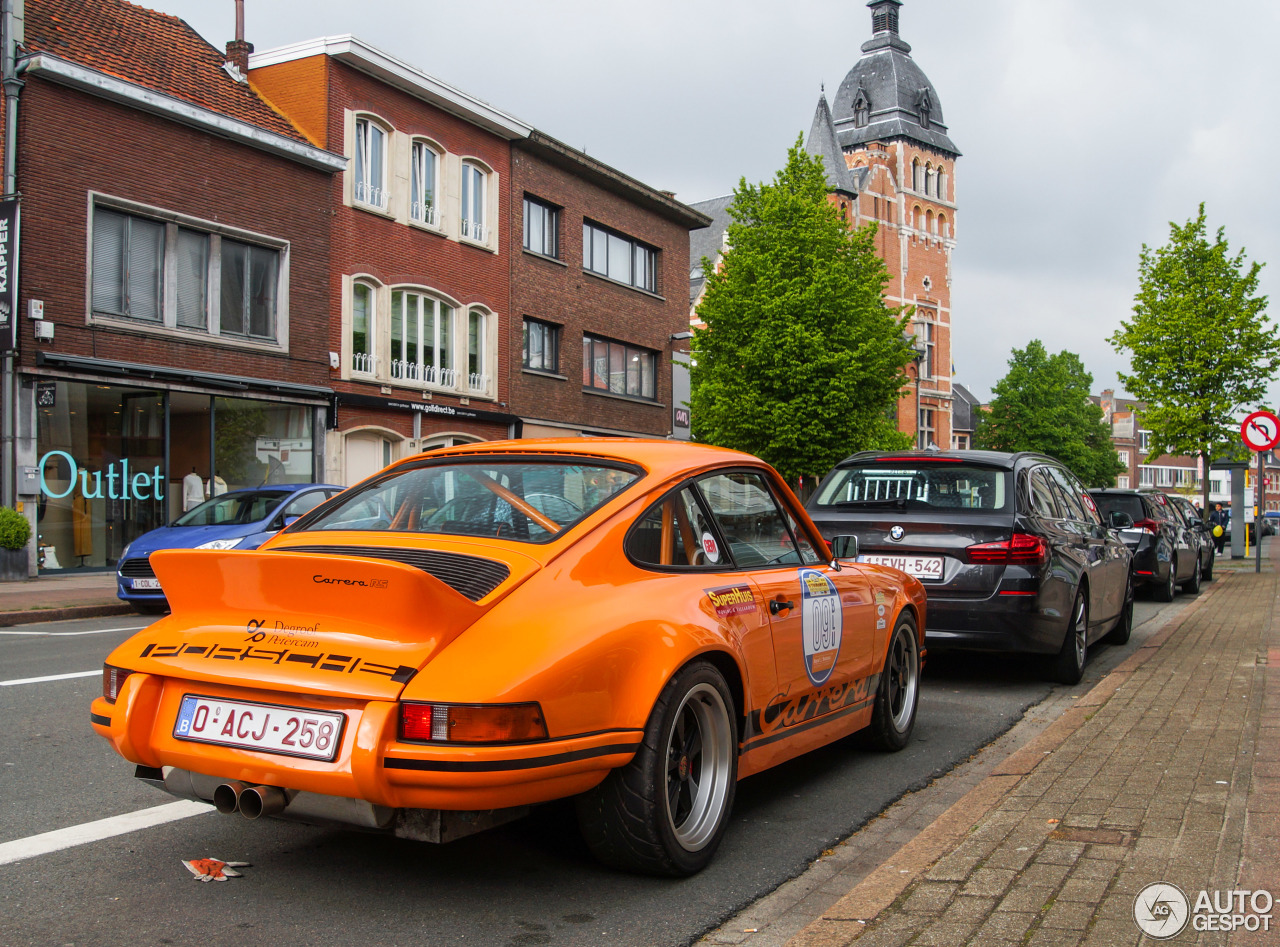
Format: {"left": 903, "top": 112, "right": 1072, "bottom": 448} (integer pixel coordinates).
{"left": 576, "top": 662, "right": 737, "bottom": 878}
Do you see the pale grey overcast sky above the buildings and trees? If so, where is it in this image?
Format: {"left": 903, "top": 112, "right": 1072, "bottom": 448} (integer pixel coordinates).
{"left": 157, "top": 0, "right": 1280, "bottom": 403}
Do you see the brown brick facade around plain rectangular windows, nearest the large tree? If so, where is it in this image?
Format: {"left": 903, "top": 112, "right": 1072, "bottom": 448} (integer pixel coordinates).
{"left": 507, "top": 145, "right": 689, "bottom": 436}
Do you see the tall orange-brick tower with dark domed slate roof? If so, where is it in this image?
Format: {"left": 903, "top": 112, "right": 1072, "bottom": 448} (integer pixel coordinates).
{"left": 806, "top": 0, "right": 970, "bottom": 449}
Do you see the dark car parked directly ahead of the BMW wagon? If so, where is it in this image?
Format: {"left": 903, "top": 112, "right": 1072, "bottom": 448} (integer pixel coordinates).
{"left": 1089, "top": 488, "right": 1213, "bottom": 601}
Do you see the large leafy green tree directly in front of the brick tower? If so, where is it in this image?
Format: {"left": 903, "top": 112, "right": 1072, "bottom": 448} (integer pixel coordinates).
{"left": 690, "top": 142, "right": 914, "bottom": 482}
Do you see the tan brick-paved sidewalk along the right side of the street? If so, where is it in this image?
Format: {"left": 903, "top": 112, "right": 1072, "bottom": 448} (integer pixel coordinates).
{"left": 762, "top": 544, "right": 1280, "bottom": 947}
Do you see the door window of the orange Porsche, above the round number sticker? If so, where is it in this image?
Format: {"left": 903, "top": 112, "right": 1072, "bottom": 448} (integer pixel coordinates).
{"left": 698, "top": 471, "right": 801, "bottom": 568}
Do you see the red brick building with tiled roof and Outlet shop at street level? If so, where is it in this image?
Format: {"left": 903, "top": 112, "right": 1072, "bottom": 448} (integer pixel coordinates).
{"left": 5, "top": 0, "right": 344, "bottom": 571}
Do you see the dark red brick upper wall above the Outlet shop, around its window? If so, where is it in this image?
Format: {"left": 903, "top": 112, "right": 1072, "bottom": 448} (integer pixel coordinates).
{"left": 18, "top": 77, "right": 330, "bottom": 385}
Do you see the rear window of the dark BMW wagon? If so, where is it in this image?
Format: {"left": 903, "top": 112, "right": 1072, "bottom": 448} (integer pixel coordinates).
{"left": 817, "top": 459, "right": 1012, "bottom": 513}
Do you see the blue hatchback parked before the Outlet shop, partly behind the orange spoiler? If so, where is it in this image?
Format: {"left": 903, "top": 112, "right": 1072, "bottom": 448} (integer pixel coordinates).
{"left": 115, "top": 484, "right": 346, "bottom": 614}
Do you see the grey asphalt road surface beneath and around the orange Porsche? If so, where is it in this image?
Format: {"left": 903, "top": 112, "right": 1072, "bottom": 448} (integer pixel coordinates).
{"left": 0, "top": 596, "right": 1187, "bottom": 947}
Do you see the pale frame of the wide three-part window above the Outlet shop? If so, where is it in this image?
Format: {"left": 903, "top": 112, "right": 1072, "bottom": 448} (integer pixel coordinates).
{"left": 84, "top": 191, "right": 291, "bottom": 352}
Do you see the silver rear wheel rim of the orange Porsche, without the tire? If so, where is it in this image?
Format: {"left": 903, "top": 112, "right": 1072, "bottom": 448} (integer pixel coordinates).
{"left": 663, "top": 683, "right": 735, "bottom": 851}
